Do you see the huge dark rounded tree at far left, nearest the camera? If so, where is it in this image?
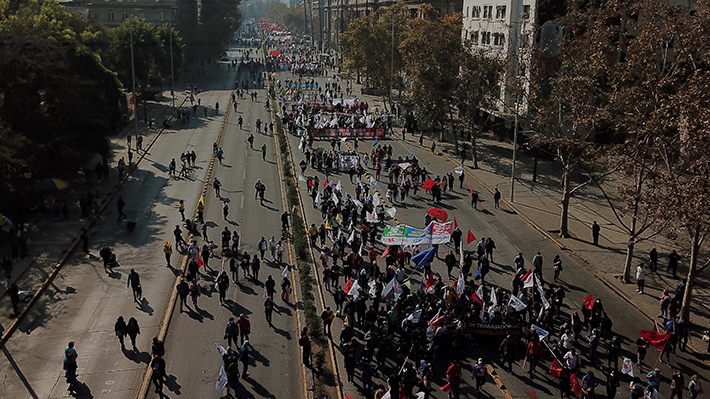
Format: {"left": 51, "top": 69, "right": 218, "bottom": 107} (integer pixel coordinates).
{"left": 0, "top": 0, "right": 122, "bottom": 170}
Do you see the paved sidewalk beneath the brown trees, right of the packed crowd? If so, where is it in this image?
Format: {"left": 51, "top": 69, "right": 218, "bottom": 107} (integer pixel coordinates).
{"left": 346, "top": 81, "right": 710, "bottom": 350}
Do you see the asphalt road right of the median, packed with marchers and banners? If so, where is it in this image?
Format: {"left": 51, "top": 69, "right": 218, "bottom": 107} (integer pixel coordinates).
{"left": 280, "top": 68, "right": 703, "bottom": 399}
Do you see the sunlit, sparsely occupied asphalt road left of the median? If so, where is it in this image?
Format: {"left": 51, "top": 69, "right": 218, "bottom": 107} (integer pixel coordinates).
{"left": 0, "top": 41, "right": 303, "bottom": 399}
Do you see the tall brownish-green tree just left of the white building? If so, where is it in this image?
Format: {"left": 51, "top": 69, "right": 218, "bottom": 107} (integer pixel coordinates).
{"left": 400, "top": 4, "right": 463, "bottom": 140}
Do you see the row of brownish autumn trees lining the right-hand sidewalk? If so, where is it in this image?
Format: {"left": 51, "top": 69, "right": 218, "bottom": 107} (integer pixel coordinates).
{"left": 341, "top": 0, "right": 710, "bottom": 320}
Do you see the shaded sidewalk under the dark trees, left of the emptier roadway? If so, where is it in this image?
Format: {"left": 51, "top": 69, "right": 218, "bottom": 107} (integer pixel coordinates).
{"left": 0, "top": 90, "right": 185, "bottom": 342}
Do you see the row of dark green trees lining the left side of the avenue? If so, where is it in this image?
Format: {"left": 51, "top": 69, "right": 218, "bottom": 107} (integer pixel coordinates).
{"left": 0, "top": 0, "right": 183, "bottom": 171}
